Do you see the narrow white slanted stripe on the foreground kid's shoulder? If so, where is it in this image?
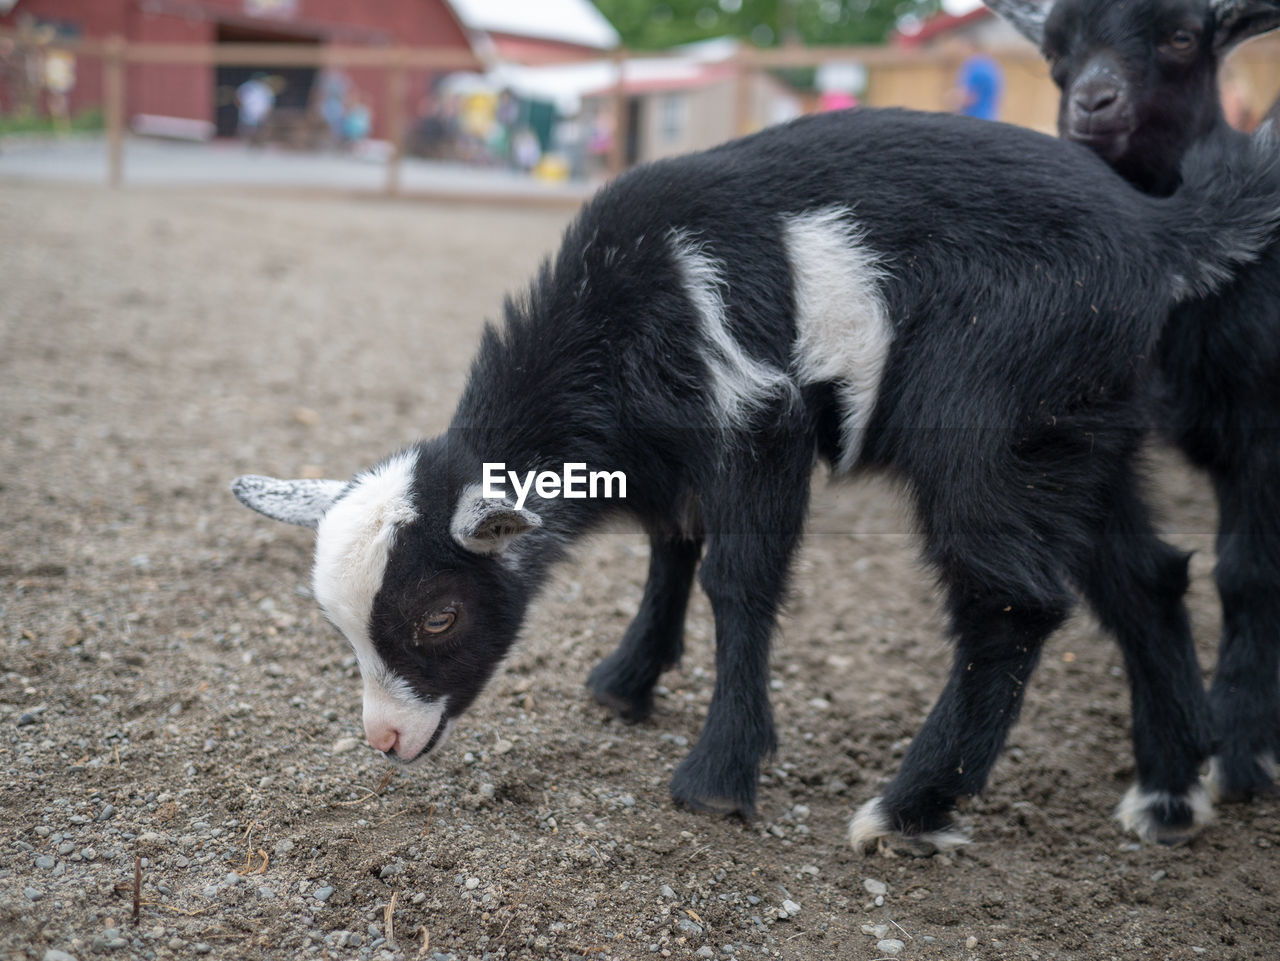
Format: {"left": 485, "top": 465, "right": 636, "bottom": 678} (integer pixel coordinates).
{"left": 671, "top": 230, "right": 795, "bottom": 427}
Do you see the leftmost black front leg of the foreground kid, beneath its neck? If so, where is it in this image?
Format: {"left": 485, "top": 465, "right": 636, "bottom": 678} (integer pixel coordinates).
{"left": 586, "top": 535, "right": 703, "bottom": 722}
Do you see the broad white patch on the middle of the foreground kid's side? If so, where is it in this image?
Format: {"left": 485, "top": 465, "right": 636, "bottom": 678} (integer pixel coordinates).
{"left": 782, "top": 207, "right": 893, "bottom": 471}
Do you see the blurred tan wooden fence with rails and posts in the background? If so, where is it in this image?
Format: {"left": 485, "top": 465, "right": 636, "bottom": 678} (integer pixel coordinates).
{"left": 0, "top": 29, "right": 1280, "bottom": 195}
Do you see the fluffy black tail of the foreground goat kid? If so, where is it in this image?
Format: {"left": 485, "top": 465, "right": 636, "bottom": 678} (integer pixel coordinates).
{"left": 1157, "top": 129, "right": 1280, "bottom": 302}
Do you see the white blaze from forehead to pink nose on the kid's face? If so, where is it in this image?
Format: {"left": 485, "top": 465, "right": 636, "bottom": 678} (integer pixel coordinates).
{"left": 311, "top": 450, "right": 444, "bottom": 759}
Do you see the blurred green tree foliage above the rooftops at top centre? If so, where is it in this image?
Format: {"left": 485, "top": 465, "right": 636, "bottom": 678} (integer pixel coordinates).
{"left": 594, "top": 0, "right": 938, "bottom": 50}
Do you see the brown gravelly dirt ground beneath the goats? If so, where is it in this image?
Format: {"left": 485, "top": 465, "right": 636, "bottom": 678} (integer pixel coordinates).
{"left": 0, "top": 182, "right": 1280, "bottom": 961}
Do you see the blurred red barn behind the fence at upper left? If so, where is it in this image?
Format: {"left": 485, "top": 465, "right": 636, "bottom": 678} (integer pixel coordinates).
{"left": 0, "top": 0, "right": 479, "bottom": 134}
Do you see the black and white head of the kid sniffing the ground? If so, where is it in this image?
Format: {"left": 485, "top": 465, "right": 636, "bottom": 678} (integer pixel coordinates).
{"left": 232, "top": 441, "right": 541, "bottom": 763}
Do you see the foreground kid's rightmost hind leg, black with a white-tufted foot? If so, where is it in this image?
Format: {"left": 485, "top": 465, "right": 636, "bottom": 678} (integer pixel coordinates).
{"left": 1073, "top": 479, "right": 1212, "bottom": 845}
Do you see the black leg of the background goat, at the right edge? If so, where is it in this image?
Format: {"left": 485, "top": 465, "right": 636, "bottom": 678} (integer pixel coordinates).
{"left": 1207, "top": 470, "right": 1280, "bottom": 801}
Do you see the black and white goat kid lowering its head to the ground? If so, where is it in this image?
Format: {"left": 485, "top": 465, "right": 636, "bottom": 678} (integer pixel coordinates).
{"left": 234, "top": 111, "right": 1280, "bottom": 847}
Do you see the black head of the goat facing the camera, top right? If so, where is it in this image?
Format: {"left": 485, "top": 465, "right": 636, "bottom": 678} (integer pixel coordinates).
{"left": 987, "top": 0, "right": 1280, "bottom": 193}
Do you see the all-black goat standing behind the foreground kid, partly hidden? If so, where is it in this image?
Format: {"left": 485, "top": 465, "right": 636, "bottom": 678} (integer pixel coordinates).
{"left": 988, "top": 0, "right": 1280, "bottom": 800}
